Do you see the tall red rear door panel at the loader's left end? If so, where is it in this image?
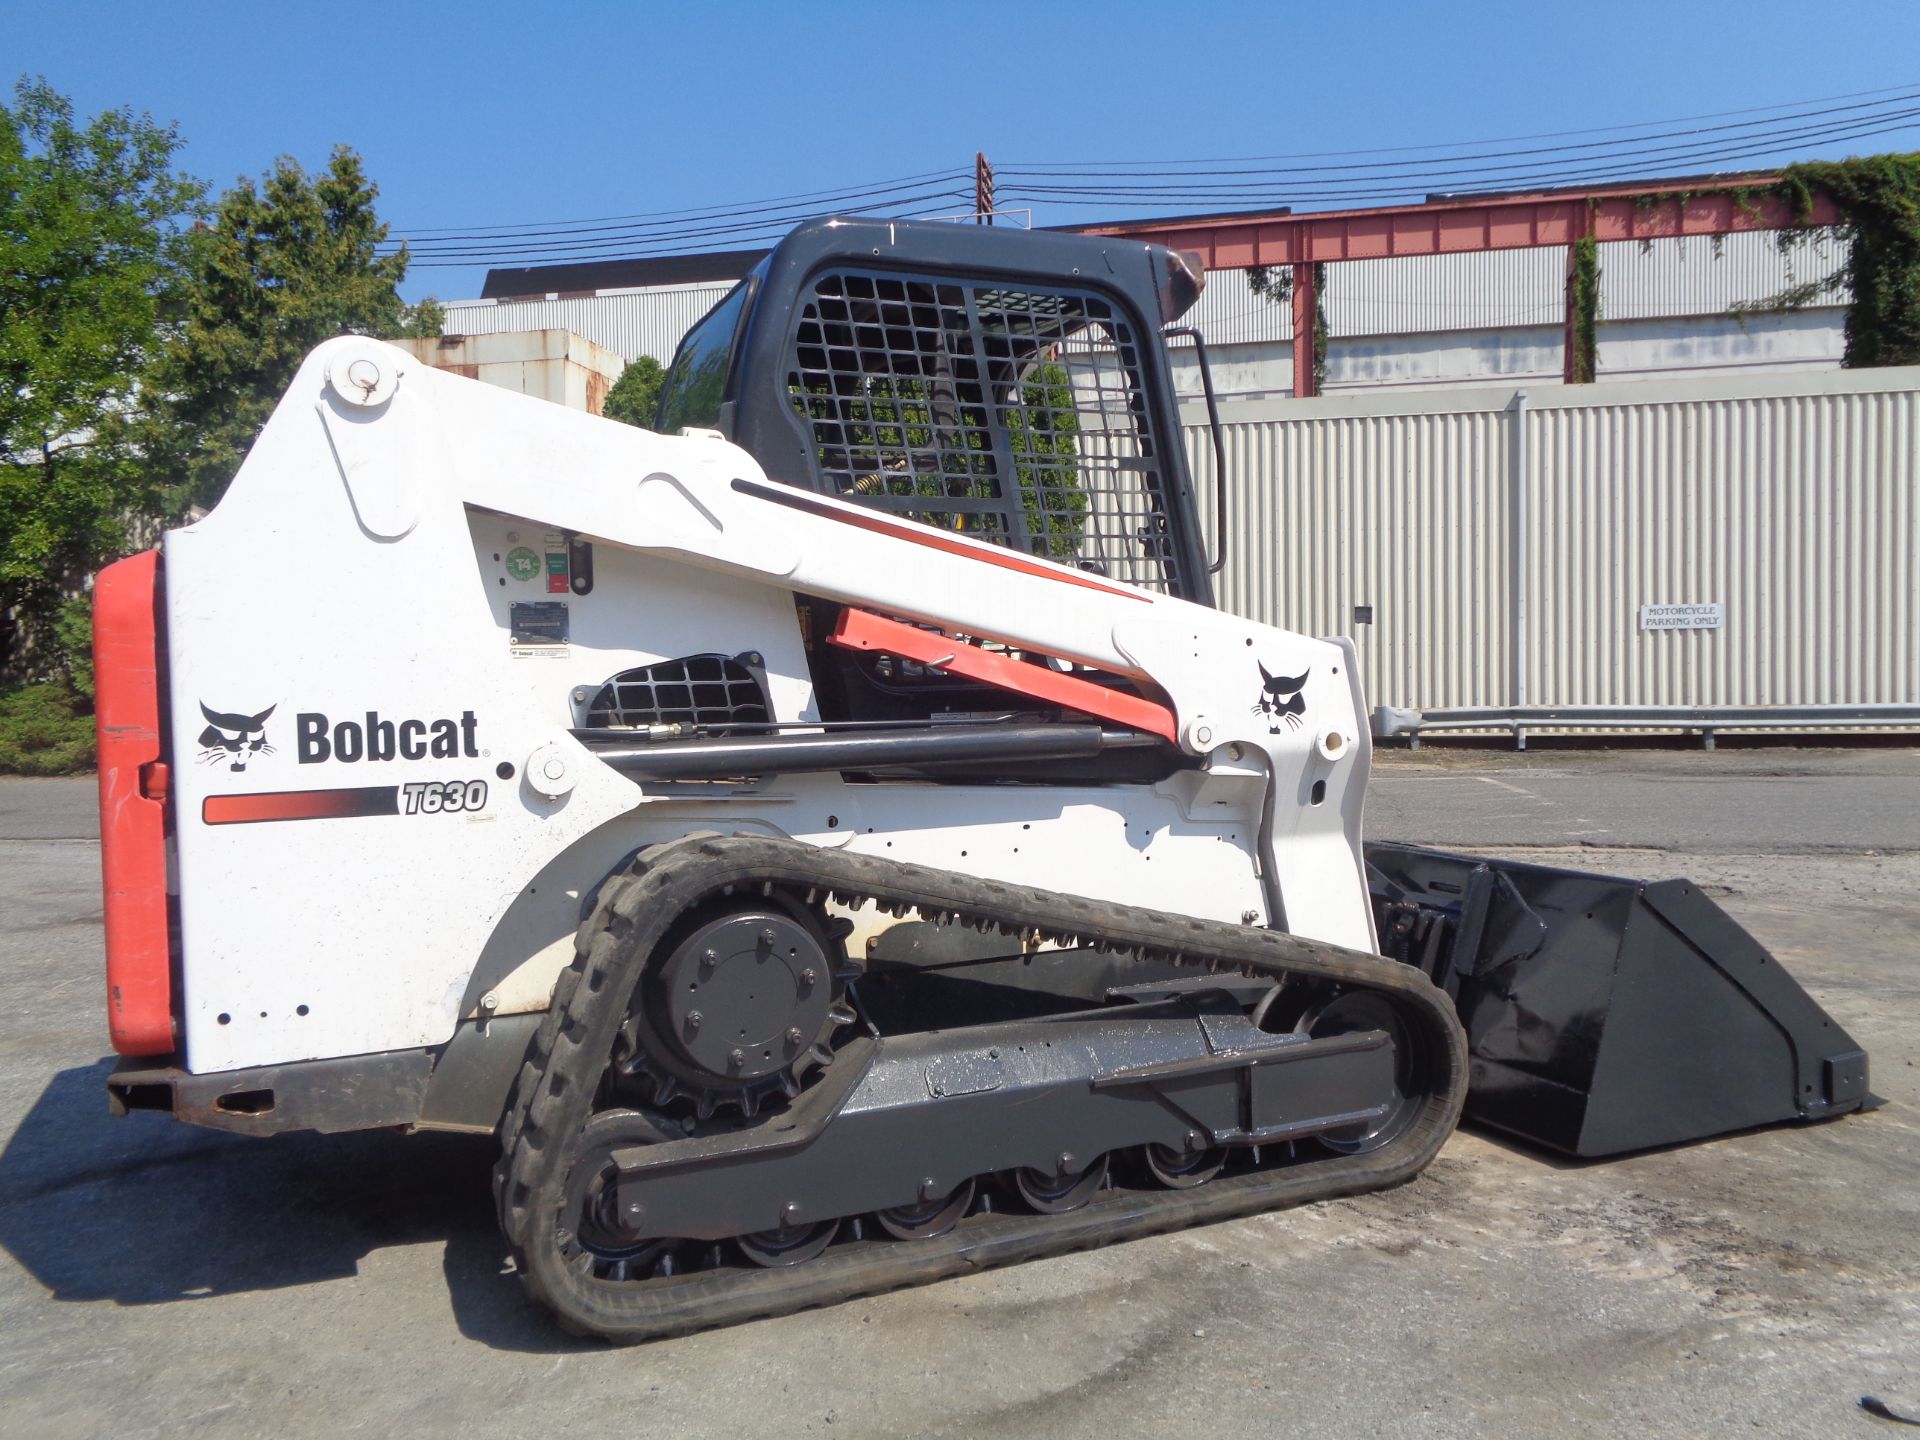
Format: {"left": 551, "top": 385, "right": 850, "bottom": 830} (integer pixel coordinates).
{"left": 94, "top": 549, "right": 175, "bottom": 1056}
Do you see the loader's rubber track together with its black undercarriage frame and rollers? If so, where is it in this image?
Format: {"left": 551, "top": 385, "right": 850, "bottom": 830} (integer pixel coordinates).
{"left": 495, "top": 837, "right": 1465, "bottom": 1340}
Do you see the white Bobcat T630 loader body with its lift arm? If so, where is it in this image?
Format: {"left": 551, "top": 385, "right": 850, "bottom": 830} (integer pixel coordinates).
{"left": 163, "top": 338, "right": 1375, "bottom": 1073}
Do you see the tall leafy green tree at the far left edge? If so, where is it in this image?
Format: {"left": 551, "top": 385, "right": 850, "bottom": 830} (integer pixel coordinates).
{"left": 0, "top": 79, "right": 204, "bottom": 670}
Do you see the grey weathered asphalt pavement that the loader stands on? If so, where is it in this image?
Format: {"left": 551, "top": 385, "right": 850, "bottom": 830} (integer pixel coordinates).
{"left": 0, "top": 749, "right": 1920, "bottom": 1440}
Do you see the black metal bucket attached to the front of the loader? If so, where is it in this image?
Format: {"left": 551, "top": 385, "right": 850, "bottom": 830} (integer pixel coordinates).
{"left": 1367, "top": 845, "right": 1872, "bottom": 1156}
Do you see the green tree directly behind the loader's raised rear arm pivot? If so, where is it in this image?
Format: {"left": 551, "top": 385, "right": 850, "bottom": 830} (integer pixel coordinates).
{"left": 146, "top": 146, "right": 428, "bottom": 509}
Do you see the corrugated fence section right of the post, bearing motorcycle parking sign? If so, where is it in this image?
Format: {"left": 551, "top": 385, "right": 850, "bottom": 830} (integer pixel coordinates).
{"left": 1526, "top": 376, "right": 1920, "bottom": 705}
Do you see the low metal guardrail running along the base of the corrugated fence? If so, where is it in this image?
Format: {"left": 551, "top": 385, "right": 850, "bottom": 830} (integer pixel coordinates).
{"left": 1373, "top": 705, "right": 1920, "bottom": 751}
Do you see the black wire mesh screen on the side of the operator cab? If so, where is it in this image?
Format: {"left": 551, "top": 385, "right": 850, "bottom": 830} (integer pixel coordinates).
{"left": 787, "top": 271, "right": 1177, "bottom": 589}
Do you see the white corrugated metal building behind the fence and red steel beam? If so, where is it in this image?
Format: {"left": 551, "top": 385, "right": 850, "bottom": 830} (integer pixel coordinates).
{"left": 445, "top": 230, "right": 1845, "bottom": 397}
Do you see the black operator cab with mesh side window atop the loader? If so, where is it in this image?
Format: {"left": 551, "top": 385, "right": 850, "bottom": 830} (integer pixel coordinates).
{"left": 655, "top": 219, "right": 1213, "bottom": 760}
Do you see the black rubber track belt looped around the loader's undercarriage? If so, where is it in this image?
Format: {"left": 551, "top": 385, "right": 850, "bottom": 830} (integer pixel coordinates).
{"left": 493, "top": 835, "right": 1467, "bottom": 1342}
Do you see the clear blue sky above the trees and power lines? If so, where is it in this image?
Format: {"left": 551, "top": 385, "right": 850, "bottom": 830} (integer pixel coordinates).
{"left": 11, "top": 0, "right": 1920, "bottom": 300}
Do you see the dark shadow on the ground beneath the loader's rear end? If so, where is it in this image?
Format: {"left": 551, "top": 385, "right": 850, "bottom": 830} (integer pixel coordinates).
{"left": 0, "top": 1060, "right": 582, "bottom": 1354}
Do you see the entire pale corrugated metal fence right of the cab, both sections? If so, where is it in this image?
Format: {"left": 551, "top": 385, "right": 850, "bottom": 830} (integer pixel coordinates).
{"left": 1187, "top": 369, "right": 1920, "bottom": 725}
